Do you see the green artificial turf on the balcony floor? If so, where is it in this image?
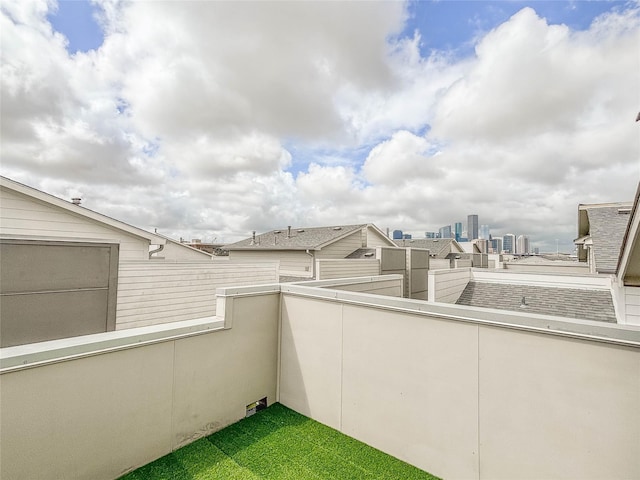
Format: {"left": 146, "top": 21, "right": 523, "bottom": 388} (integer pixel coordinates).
{"left": 121, "top": 403, "right": 437, "bottom": 480}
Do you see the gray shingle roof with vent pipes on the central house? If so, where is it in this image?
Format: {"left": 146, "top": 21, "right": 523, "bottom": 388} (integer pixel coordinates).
{"left": 225, "top": 224, "right": 366, "bottom": 250}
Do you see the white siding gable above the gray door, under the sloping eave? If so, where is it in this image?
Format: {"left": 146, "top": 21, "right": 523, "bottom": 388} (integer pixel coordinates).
{"left": 0, "top": 189, "right": 149, "bottom": 260}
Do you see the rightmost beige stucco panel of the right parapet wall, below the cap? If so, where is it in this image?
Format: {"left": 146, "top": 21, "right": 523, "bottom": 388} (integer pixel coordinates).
{"left": 479, "top": 327, "right": 640, "bottom": 480}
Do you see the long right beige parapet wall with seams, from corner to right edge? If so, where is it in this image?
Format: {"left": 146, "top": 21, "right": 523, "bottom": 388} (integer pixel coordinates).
{"left": 279, "top": 285, "right": 640, "bottom": 480}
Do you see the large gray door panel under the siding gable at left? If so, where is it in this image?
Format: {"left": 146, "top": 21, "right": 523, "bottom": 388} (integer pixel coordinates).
{"left": 0, "top": 239, "right": 118, "bottom": 347}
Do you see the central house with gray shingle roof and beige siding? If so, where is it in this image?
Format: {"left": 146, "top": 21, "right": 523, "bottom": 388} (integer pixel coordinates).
{"left": 225, "top": 224, "right": 395, "bottom": 278}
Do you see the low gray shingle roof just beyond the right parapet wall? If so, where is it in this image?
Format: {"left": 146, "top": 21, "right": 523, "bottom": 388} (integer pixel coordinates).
{"left": 456, "top": 281, "right": 616, "bottom": 323}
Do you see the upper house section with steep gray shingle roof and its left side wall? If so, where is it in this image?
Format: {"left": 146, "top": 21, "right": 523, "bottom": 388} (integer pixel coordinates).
{"left": 574, "top": 202, "right": 633, "bottom": 274}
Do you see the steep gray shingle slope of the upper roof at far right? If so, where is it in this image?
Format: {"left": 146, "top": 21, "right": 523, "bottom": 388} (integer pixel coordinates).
{"left": 586, "top": 206, "right": 630, "bottom": 273}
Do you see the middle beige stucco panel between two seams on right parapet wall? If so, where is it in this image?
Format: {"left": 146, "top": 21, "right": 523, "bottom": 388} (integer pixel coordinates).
{"left": 342, "top": 306, "right": 478, "bottom": 478}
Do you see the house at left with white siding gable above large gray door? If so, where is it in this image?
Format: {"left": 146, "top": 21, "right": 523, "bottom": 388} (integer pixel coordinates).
{"left": 0, "top": 177, "right": 211, "bottom": 347}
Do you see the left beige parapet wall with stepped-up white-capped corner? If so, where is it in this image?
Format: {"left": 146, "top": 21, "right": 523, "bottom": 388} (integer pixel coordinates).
{"left": 0, "top": 287, "right": 280, "bottom": 480}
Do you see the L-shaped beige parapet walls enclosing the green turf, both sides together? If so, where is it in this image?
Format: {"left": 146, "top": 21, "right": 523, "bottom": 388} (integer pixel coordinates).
{"left": 0, "top": 275, "right": 640, "bottom": 479}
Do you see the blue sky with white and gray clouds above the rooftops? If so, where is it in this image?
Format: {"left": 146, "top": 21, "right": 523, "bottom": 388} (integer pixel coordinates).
{"left": 0, "top": 0, "right": 640, "bottom": 251}
